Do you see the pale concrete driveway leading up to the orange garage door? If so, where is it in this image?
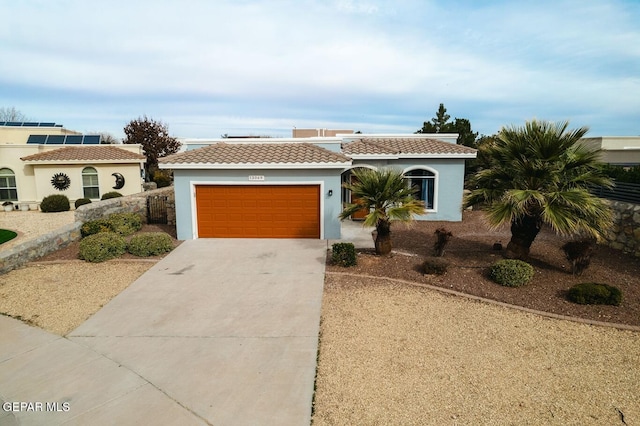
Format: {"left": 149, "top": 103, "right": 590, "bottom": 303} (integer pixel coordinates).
{"left": 0, "top": 239, "right": 327, "bottom": 425}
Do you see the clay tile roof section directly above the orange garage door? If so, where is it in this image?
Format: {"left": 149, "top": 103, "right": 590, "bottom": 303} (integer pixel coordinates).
{"left": 159, "top": 142, "right": 351, "bottom": 164}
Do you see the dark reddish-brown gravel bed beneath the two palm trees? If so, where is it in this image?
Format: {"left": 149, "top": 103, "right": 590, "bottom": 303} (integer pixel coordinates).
{"left": 327, "top": 211, "right": 640, "bottom": 326}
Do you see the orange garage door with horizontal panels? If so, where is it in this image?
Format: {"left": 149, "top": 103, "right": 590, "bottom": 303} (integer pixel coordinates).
{"left": 196, "top": 185, "right": 320, "bottom": 238}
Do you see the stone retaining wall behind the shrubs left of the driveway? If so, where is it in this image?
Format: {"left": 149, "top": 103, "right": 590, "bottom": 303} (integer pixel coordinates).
{"left": 0, "top": 187, "right": 176, "bottom": 274}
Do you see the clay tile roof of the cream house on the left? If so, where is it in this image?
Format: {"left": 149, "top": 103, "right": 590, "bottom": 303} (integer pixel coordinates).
{"left": 20, "top": 145, "right": 146, "bottom": 162}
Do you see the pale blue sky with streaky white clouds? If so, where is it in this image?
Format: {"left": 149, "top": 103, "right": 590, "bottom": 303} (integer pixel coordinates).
{"left": 0, "top": 0, "right": 640, "bottom": 138}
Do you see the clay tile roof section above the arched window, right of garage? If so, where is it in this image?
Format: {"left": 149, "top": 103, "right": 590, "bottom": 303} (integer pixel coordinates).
{"left": 342, "top": 138, "right": 476, "bottom": 155}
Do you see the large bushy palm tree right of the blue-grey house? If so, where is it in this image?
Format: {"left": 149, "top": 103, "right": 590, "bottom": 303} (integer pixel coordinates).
{"left": 464, "top": 120, "right": 612, "bottom": 259}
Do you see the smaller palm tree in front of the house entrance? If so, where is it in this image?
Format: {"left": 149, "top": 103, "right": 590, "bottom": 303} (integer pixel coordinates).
{"left": 339, "top": 168, "right": 425, "bottom": 255}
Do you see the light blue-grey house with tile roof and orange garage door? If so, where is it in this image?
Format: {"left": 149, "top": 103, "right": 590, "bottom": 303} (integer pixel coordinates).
{"left": 159, "top": 134, "right": 476, "bottom": 239}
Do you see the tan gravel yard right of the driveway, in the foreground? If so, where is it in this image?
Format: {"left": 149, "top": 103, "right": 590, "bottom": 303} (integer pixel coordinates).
{"left": 313, "top": 274, "right": 640, "bottom": 426}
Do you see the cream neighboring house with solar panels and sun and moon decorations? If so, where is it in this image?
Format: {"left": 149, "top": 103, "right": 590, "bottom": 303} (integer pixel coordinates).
{"left": 0, "top": 122, "right": 146, "bottom": 206}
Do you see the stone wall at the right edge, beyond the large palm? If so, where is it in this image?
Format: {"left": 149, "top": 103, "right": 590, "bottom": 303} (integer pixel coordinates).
{"left": 605, "top": 201, "right": 640, "bottom": 257}
